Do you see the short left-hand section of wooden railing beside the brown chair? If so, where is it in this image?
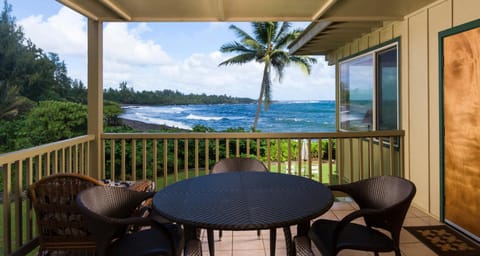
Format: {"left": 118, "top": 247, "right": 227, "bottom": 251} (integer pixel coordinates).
{"left": 0, "top": 135, "right": 95, "bottom": 255}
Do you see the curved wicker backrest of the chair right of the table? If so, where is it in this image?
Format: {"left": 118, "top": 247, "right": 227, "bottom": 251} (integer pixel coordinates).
{"left": 340, "top": 176, "right": 416, "bottom": 235}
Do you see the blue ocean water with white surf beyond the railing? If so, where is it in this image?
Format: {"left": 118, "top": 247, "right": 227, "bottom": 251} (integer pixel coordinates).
{"left": 121, "top": 101, "right": 335, "bottom": 132}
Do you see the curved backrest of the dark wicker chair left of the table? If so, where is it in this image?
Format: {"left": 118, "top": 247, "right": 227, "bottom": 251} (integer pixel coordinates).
{"left": 76, "top": 186, "right": 154, "bottom": 255}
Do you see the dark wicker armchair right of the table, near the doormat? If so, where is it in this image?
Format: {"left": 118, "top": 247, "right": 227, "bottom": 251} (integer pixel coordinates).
{"left": 308, "top": 176, "right": 416, "bottom": 256}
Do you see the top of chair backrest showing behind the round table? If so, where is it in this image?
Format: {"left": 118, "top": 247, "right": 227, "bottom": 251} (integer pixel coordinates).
{"left": 212, "top": 157, "right": 268, "bottom": 173}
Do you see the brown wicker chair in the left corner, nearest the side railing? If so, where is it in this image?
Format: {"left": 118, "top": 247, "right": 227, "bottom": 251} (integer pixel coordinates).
{"left": 27, "top": 174, "right": 103, "bottom": 255}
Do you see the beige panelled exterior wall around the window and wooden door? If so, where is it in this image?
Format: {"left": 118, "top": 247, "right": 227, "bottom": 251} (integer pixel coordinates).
{"left": 327, "top": 0, "right": 480, "bottom": 218}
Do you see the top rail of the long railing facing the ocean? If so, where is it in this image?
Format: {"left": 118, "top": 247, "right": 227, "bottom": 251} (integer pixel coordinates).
{"left": 101, "top": 130, "right": 405, "bottom": 139}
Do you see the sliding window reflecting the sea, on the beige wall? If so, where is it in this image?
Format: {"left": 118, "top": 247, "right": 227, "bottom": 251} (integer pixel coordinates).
{"left": 340, "top": 43, "right": 399, "bottom": 131}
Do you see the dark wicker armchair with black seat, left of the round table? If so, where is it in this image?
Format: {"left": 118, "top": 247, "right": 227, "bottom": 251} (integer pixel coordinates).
{"left": 76, "top": 186, "right": 184, "bottom": 256}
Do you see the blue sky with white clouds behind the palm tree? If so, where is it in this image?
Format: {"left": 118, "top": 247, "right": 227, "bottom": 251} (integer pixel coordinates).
{"left": 8, "top": 0, "right": 335, "bottom": 101}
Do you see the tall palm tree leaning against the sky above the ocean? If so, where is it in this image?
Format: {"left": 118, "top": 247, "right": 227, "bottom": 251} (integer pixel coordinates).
{"left": 219, "top": 22, "right": 317, "bottom": 131}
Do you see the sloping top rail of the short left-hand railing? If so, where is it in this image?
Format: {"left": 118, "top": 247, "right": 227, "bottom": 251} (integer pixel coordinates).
{"left": 0, "top": 135, "right": 95, "bottom": 166}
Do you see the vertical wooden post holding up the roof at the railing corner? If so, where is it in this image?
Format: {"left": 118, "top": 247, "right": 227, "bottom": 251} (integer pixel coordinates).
{"left": 88, "top": 19, "right": 103, "bottom": 179}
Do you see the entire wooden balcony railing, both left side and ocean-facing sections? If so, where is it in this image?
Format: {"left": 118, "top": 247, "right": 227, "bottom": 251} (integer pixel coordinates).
{"left": 0, "top": 131, "right": 404, "bottom": 255}
